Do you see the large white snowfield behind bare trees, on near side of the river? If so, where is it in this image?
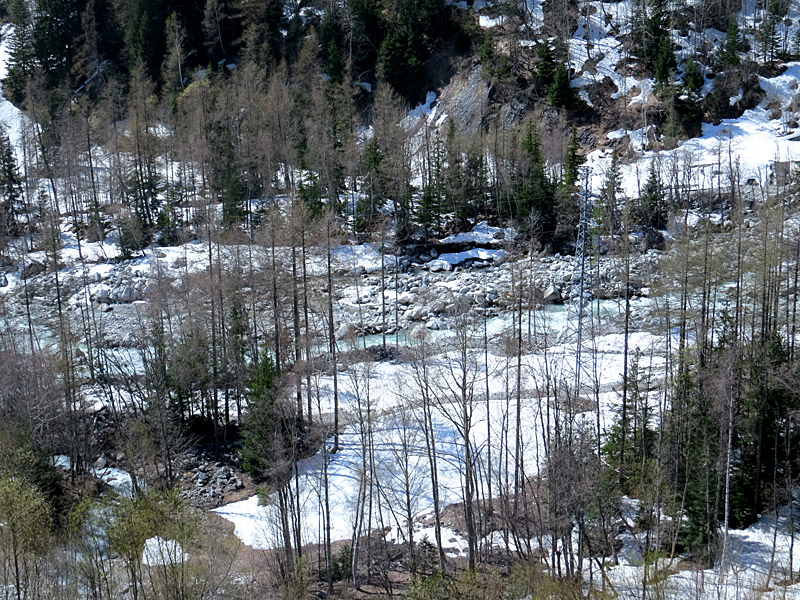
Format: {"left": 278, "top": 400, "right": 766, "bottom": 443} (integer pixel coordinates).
{"left": 215, "top": 310, "right": 665, "bottom": 553}
